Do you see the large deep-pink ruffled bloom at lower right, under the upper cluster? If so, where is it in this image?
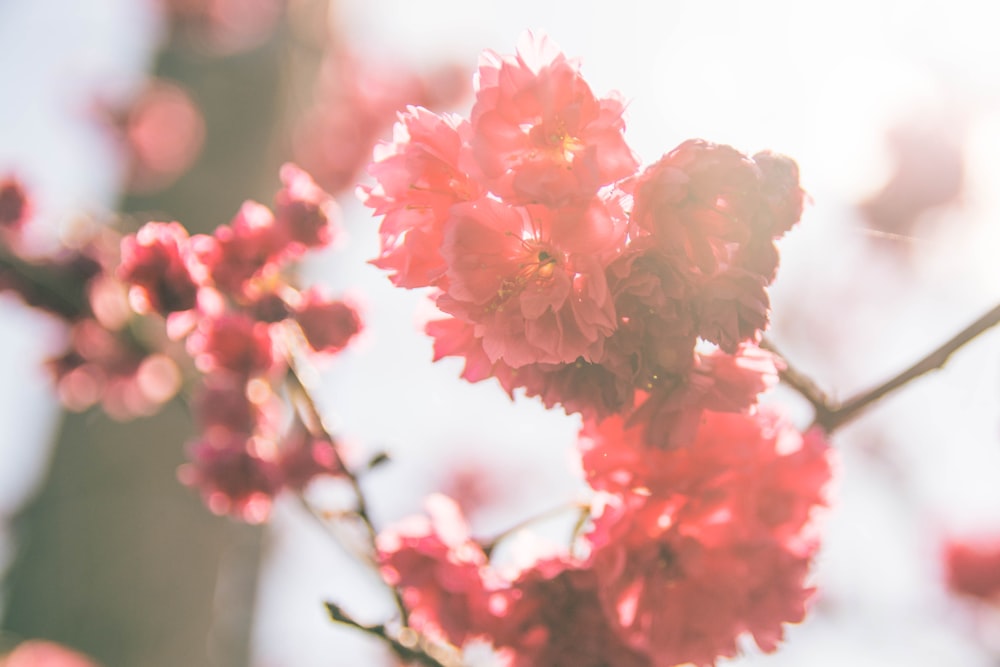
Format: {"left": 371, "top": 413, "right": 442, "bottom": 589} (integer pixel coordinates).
{"left": 581, "top": 412, "right": 830, "bottom": 667}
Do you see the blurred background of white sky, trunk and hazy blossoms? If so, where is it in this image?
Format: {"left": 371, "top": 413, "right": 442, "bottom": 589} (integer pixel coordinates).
{"left": 0, "top": 0, "right": 1000, "bottom": 667}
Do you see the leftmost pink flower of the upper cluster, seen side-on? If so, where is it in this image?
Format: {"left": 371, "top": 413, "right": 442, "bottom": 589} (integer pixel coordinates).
{"left": 358, "top": 107, "right": 482, "bottom": 288}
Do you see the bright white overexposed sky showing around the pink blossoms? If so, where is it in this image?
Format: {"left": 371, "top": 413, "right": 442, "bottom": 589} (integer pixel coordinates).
{"left": 0, "top": 0, "right": 1000, "bottom": 667}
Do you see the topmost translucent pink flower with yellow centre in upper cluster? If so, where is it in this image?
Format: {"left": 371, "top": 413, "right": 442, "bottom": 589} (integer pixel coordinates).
{"left": 471, "top": 32, "right": 638, "bottom": 206}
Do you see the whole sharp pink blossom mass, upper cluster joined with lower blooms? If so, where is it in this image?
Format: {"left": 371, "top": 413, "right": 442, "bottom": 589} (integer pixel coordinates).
{"left": 359, "top": 34, "right": 830, "bottom": 667}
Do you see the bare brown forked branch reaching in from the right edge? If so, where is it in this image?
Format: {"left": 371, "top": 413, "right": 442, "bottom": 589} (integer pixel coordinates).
{"left": 761, "top": 304, "right": 1000, "bottom": 433}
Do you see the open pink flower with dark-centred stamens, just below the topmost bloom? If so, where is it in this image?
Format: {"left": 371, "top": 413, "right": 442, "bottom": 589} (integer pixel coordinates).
{"left": 437, "top": 199, "right": 615, "bottom": 368}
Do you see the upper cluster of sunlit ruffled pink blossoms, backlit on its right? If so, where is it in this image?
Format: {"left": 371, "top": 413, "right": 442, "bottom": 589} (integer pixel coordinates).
{"left": 360, "top": 34, "right": 803, "bottom": 446}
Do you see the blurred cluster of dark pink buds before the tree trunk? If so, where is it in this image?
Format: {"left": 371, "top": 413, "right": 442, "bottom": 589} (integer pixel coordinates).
{"left": 0, "top": 164, "right": 361, "bottom": 521}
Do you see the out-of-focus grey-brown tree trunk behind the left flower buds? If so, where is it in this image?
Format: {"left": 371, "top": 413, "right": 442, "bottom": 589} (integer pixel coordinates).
{"left": 3, "top": 20, "right": 287, "bottom": 667}
